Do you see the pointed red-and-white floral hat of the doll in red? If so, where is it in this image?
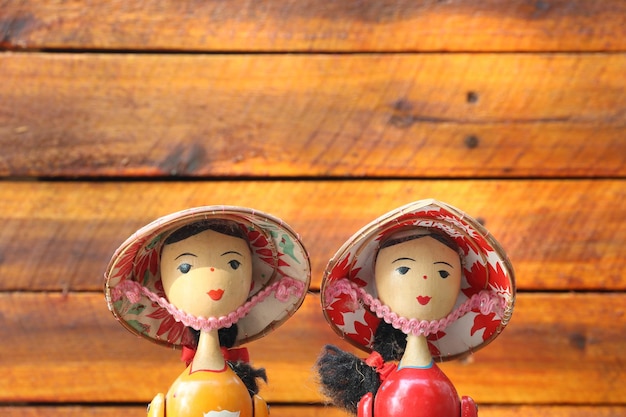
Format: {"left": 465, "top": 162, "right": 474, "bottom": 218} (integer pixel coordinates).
{"left": 321, "top": 199, "right": 515, "bottom": 361}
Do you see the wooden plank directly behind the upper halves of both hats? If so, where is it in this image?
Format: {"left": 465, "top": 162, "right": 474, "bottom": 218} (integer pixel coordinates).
{"left": 0, "top": 180, "right": 626, "bottom": 292}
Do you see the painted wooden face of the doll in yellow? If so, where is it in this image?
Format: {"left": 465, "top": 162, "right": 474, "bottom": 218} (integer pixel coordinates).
{"left": 161, "top": 230, "right": 252, "bottom": 317}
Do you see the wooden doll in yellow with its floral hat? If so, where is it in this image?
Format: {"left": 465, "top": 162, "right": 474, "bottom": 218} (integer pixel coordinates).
{"left": 105, "top": 206, "right": 310, "bottom": 417}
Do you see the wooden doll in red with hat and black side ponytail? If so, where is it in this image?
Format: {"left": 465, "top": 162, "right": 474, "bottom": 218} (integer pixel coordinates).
{"left": 316, "top": 200, "right": 515, "bottom": 417}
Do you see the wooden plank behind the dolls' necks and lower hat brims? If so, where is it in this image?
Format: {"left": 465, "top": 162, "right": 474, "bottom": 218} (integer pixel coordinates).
{"left": 0, "top": 293, "right": 626, "bottom": 405}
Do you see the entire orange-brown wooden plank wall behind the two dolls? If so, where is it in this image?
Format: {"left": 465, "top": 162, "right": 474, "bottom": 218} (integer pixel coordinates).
{"left": 0, "top": 0, "right": 626, "bottom": 417}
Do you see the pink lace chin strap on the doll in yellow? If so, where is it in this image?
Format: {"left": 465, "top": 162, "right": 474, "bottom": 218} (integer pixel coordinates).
{"left": 111, "top": 277, "right": 304, "bottom": 331}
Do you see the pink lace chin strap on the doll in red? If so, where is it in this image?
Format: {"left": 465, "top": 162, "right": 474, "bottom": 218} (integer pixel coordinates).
{"left": 326, "top": 278, "right": 507, "bottom": 336}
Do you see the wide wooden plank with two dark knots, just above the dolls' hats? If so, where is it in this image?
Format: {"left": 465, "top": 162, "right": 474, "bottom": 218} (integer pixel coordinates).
{"left": 0, "top": 52, "right": 626, "bottom": 178}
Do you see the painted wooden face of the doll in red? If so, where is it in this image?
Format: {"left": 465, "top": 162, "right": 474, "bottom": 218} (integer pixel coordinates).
{"left": 375, "top": 235, "right": 461, "bottom": 320}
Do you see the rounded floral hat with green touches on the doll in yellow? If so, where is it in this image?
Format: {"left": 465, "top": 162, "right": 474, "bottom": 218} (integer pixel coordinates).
{"left": 104, "top": 206, "right": 311, "bottom": 347}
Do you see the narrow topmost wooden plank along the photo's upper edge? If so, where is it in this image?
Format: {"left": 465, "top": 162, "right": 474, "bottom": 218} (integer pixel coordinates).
{"left": 0, "top": 0, "right": 626, "bottom": 52}
